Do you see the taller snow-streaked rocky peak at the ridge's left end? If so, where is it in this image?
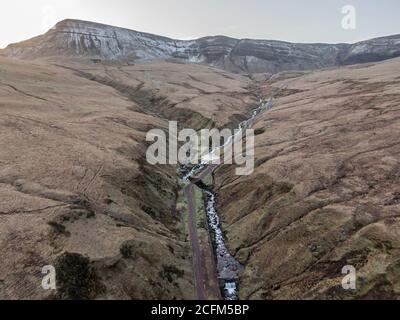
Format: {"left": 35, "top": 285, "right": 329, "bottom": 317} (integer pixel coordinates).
{"left": 2, "top": 20, "right": 197, "bottom": 60}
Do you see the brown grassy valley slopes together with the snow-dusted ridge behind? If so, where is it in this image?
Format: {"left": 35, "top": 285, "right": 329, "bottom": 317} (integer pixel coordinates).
{"left": 0, "top": 20, "right": 400, "bottom": 300}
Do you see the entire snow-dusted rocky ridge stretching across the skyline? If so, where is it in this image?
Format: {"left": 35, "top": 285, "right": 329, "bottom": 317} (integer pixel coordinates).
{"left": 3, "top": 20, "right": 400, "bottom": 73}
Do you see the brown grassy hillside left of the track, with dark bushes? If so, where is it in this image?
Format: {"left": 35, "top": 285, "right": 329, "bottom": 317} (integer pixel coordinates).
{"left": 0, "top": 58, "right": 254, "bottom": 299}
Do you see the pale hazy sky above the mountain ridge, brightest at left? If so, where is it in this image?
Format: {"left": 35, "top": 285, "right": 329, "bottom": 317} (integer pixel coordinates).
{"left": 0, "top": 0, "right": 400, "bottom": 48}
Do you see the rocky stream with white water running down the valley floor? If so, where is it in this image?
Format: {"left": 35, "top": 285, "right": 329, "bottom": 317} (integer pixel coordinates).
{"left": 183, "top": 97, "right": 273, "bottom": 300}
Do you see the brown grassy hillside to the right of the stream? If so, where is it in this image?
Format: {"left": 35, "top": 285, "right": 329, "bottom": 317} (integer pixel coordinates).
{"left": 215, "top": 59, "right": 400, "bottom": 299}
